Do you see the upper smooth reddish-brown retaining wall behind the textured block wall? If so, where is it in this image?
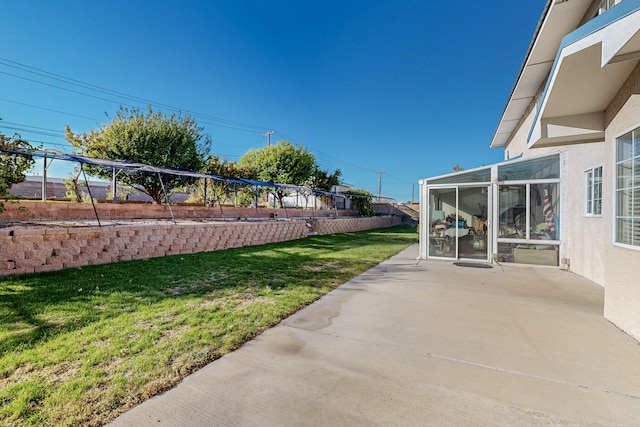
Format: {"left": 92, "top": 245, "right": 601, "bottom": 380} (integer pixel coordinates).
{"left": 0, "top": 200, "right": 355, "bottom": 221}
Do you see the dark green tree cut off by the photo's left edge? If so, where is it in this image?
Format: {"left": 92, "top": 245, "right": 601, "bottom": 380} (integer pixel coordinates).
{"left": 0, "top": 133, "right": 34, "bottom": 213}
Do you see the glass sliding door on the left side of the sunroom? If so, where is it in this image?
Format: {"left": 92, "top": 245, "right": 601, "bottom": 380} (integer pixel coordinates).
{"left": 428, "top": 186, "right": 489, "bottom": 260}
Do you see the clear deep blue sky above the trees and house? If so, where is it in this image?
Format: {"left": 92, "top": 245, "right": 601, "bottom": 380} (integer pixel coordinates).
{"left": 0, "top": 0, "right": 545, "bottom": 202}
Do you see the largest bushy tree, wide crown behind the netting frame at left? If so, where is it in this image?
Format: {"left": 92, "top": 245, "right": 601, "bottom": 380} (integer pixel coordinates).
{"left": 65, "top": 107, "right": 210, "bottom": 203}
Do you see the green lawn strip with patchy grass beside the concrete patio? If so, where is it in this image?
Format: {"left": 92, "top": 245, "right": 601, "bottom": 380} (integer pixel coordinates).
{"left": 0, "top": 226, "right": 417, "bottom": 426}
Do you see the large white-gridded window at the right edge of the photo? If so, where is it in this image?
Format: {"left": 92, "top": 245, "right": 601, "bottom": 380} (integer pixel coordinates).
{"left": 615, "top": 128, "right": 640, "bottom": 248}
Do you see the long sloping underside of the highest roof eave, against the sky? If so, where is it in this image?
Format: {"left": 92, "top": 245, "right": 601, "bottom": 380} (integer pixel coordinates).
{"left": 491, "top": 0, "right": 591, "bottom": 148}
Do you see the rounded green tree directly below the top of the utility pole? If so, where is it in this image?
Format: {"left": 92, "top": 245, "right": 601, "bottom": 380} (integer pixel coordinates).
{"left": 240, "top": 140, "right": 318, "bottom": 207}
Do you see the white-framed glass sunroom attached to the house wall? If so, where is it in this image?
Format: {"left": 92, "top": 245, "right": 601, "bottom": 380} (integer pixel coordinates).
{"left": 420, "top": 154, "right": 561, "bottom": 266}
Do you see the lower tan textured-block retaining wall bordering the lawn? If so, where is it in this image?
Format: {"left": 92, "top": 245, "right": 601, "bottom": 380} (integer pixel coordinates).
{"left": 0, "top": 217, "right": 400, "bottom": 276}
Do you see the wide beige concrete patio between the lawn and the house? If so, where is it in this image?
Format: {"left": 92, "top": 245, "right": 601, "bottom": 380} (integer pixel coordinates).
{"left": 113, "top": 246, "right": 640, "bottom": 426}
